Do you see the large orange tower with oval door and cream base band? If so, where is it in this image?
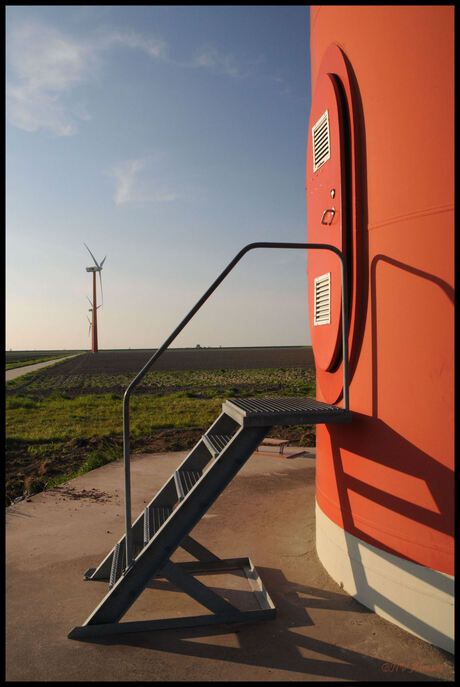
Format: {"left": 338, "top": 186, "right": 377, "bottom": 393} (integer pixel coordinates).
{"left": 306, "top": 5, "right": 455, "bottom": 653}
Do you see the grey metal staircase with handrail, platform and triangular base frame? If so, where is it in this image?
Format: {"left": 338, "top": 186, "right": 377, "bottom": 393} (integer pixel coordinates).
{"left": 68, "top": 243, "right": 351, "bottom": 639}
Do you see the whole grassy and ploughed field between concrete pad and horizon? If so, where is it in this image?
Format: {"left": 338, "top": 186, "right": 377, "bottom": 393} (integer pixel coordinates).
{"left": 5, "top": 349, "right": 315, "bottom": 504}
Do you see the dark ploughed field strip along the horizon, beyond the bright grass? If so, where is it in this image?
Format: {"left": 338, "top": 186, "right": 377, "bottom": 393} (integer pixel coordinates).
{"left": 6, "top": 348, "right": 314, "bottom": 398}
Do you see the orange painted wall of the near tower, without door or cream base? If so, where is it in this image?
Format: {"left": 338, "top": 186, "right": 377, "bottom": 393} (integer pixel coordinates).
{"left": 307, "top": 5, "right": 454, "bottom": 574}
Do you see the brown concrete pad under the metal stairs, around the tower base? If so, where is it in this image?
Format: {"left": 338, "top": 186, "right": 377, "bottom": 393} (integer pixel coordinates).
{"left": 6, "top": 449, "right": 454, "bottom": 682}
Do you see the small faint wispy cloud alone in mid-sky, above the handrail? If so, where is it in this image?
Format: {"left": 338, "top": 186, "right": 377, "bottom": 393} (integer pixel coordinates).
{"left": 109, "top": 155, "right": 188, "bottom": 205}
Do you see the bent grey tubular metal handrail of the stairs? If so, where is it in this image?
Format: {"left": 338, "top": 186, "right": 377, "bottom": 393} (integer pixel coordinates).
{"left": 123, "top": 242, "right": 348, "bottom": 570}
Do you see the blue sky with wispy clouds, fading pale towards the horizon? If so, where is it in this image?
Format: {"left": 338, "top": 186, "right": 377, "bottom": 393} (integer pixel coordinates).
{"left": 6, "top": 5, "right": 311, "bottom": 350}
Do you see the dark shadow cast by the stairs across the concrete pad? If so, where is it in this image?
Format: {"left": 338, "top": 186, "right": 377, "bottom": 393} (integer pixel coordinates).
{"left": 74, "top": 566, "right": 445, "bottom": 682}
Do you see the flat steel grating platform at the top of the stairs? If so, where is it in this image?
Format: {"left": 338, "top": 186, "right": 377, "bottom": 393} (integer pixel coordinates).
{"left": 222, "top": 396, "right": 351, "bottom": 427}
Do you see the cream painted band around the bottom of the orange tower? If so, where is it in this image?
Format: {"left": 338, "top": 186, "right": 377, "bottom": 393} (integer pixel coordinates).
{"left": 316, "top": 504, "right": 455, "bottom": 654}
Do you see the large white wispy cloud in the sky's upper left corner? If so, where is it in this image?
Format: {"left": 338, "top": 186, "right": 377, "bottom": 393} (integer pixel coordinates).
{"left": 7, "top": 22, "right": 255, "bottom": 136}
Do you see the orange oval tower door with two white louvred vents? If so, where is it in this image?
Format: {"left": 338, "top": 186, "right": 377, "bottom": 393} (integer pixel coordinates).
{"left": 306, "top": 73, "right": 346, "bottom": 371}
